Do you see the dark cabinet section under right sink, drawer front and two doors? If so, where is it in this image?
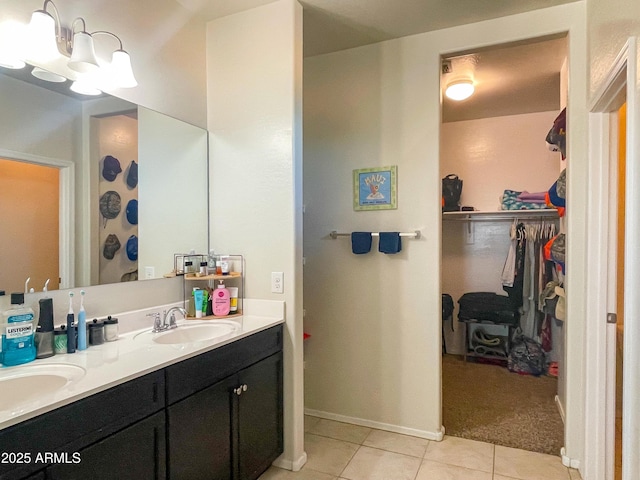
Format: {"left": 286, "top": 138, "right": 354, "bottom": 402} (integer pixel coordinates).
{"left": 167, "top": 327, "right": 283, "bottom": 480}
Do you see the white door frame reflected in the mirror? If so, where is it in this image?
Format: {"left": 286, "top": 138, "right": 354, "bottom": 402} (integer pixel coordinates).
{"left": 0, "top": 148, "right": 75, "bottom": 290}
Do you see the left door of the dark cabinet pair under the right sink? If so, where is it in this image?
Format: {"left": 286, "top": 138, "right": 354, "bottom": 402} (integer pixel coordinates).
{"left": 167, "top": 376, "right": 237, "bottom": 480}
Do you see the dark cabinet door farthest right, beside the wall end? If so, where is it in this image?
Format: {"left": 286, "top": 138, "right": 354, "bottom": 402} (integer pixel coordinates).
{"left": 233, "top": 352, "right": 283, "bottom": 480}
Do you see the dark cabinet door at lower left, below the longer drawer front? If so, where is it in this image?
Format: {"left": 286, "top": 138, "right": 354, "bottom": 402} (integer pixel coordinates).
{"left": 47, "top": 412, "right": 166, "bottom": 480}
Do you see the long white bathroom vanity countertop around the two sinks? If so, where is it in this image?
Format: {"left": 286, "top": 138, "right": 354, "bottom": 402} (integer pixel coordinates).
{"left": 0, "top": 301, "right": 284, "bottom": 429}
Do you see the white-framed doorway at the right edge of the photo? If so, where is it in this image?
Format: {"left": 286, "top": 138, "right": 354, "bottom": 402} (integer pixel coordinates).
{"left": 584, "top": 37, "right": 640, "bottom": 480}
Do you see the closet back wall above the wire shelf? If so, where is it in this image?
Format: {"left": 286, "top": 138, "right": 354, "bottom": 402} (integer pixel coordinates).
{"left": 440, "top": 110, "right": 560, "bottom": 211}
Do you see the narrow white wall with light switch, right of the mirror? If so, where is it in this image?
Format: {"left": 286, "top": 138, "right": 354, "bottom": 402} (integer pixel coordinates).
{"left": 207, "top": 0, "right": 305, "bottom": 469}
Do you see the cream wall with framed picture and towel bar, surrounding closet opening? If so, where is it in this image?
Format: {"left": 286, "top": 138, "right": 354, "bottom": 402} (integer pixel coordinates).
{"left": 304, "top": 3, "right": 586, "bottom": 460}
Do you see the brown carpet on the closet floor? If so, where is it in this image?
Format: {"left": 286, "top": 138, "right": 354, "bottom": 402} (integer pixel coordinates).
{"left": 442, "top": 355, "right": 564, "bottom": 456}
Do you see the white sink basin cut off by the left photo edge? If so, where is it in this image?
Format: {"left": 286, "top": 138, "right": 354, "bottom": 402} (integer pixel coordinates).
{"left": 0, "top": 363, "right": 86, "bottom": 411}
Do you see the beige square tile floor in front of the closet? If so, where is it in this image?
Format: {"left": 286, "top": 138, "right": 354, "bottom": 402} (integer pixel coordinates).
{"left": 260, "top": 416, "right": 580, "bottom": 480}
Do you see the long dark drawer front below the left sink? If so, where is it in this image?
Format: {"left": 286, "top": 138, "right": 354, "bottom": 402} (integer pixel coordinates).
{"left": 0, "top": 370, "right": 164, "bottom": 480}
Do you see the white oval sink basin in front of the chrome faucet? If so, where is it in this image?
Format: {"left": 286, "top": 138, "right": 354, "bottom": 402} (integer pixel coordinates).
{"left": 134, "top": 320, "right": 240, "bottom": 345}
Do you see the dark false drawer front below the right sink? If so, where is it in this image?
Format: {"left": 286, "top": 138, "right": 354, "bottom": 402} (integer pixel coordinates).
{"left": 166, "top": 325, "right": 282, "bottom": 405}
